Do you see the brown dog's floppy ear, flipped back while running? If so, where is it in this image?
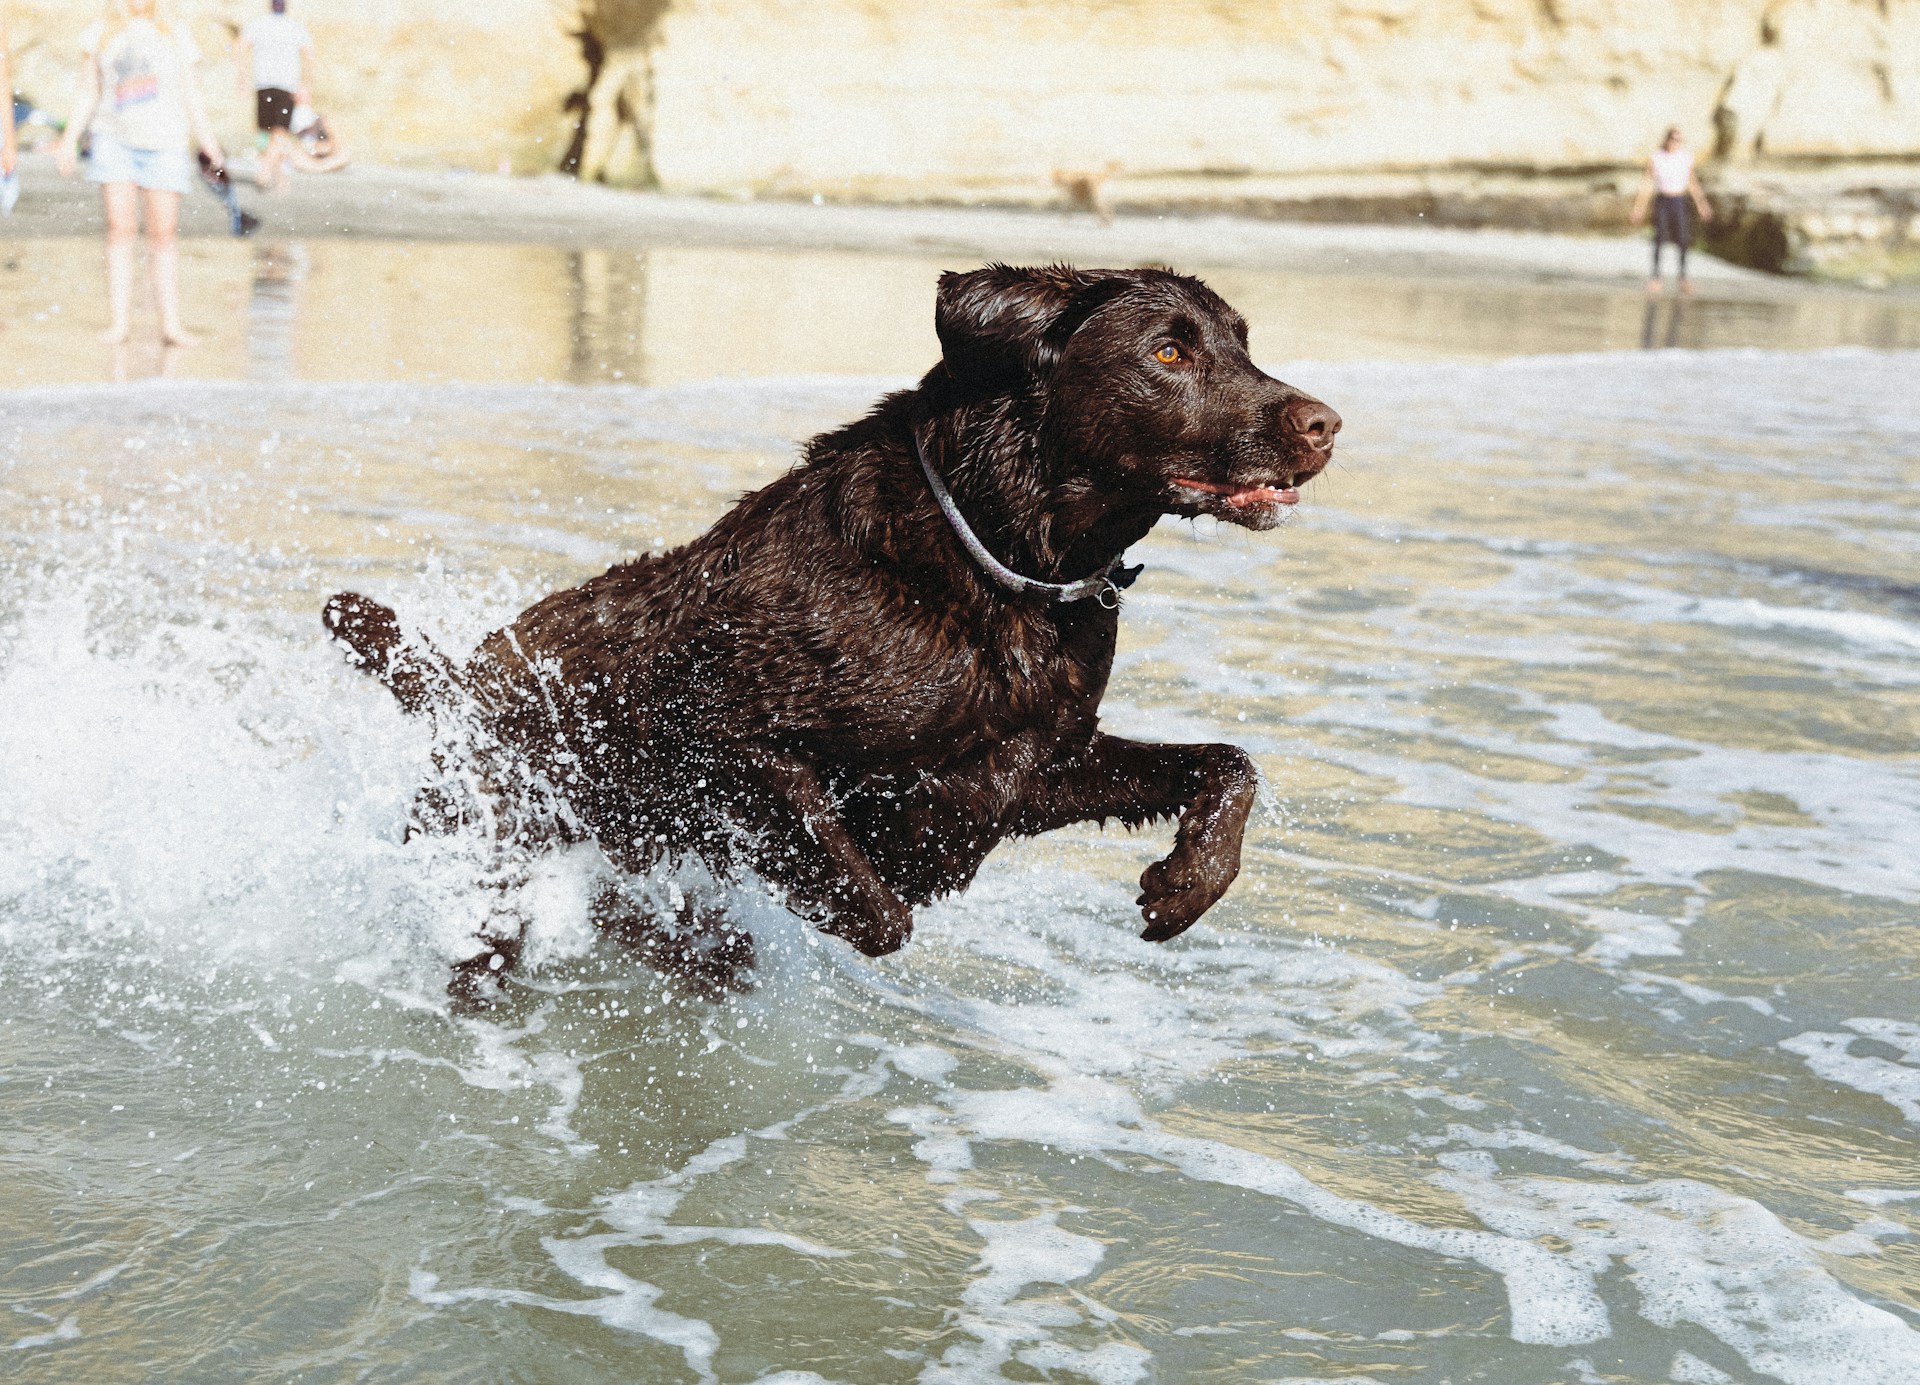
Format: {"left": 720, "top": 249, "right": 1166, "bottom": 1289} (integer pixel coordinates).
{"left": 933, "top": 265, "right": 1125, "bottom": 388}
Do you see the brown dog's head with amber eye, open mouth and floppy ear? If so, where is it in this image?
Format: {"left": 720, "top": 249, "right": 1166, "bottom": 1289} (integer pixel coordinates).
{"left": 935, "top": 265, "right": 1340, "bottom": 528}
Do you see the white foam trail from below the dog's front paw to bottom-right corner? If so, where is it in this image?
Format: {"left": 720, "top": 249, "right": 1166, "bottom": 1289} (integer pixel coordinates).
{"left": 875, "top": 864, "right": 1920, "bottom": 1383}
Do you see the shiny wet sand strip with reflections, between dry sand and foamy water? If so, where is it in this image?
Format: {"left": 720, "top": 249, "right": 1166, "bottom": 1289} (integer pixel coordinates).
{"left": 11, "top": 238, "right": 1920, "bottom": 386}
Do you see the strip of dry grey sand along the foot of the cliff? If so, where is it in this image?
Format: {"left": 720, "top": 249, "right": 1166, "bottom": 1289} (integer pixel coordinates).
{"left": 0, "top": 154, "right": 1881, "bottom": 300}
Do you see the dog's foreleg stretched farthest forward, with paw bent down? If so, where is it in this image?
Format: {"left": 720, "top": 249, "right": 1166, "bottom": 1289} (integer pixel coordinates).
{"left": 1014, "top": 736, "right": 1260, "bottom": 943}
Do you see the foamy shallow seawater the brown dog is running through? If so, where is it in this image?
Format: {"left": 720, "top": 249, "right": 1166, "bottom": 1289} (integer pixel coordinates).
{"left": 0, "top": 248, "right": 1920, "bottom": 1385}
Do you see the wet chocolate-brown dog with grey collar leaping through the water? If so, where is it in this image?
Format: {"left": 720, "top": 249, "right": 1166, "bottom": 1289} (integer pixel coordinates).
{"left": 324, "top": 265, "right": 1340, "bottom": 974}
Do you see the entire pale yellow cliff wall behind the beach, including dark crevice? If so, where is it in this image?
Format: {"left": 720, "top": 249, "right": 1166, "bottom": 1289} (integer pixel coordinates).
{"left": 12, "top": 0, "right": 1920, "bottom": 189}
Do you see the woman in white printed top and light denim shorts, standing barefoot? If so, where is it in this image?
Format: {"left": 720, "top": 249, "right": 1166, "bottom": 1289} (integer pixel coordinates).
{"left": 58, "top": 0, "right": 227, "bottom": 346}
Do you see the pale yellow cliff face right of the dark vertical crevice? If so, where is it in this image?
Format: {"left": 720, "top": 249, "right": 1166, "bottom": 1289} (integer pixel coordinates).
{"left": 633, "top": 0, "right": 1920, "bottom": 194}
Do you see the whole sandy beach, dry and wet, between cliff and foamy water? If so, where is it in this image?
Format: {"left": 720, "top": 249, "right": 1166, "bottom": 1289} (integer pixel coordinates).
{"left": 15, "top": 156, "right": 1920, "bottom": 386}
